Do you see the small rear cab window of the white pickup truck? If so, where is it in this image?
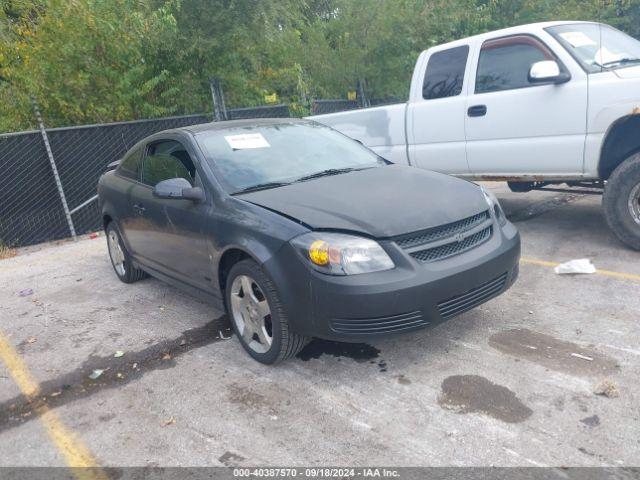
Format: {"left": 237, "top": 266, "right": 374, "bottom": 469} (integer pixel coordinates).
{"left": 422, "top": 45, "right": 469, "bottom": 100}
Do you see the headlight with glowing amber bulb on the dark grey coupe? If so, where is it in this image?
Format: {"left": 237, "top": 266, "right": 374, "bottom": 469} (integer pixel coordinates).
{"left": 291, "top": 232, "right": 395, "bottom": 275}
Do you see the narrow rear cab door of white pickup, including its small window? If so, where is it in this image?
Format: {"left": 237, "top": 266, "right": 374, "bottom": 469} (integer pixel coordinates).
{"left": 407, "top": 45, "right": 469, "bottom": 174}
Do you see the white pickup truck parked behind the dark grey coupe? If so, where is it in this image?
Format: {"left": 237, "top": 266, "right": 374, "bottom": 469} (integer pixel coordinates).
{"left": 312, "top": 22, "right": 640, "bottom": 249}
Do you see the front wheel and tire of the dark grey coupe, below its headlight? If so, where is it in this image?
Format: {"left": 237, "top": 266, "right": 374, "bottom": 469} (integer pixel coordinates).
{"left": 225, "top": 260, "right": 309, "bottom": 365}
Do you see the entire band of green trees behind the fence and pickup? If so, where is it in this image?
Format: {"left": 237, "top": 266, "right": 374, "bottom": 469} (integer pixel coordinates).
{"left": 0, "top": 0, "right": 640, "bottom": 131}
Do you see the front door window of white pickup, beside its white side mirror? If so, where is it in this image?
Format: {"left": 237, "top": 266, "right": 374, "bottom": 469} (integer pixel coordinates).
{"left": 475, "top": 35, "right": 555, "bottom": 93}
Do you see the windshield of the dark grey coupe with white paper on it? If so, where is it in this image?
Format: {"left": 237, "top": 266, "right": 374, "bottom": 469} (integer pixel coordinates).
{"left": 198, "top": 122, "right": 386, "bottom": 193}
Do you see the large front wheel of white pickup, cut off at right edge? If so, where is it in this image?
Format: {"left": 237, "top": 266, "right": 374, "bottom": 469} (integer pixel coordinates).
{"left": 602, "top": 153, "right": 640, "bottom": 250}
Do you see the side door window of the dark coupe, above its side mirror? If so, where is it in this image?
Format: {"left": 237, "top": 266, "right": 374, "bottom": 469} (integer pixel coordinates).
{"left": 142, "top": 140, "right": 196, "bottom": 187}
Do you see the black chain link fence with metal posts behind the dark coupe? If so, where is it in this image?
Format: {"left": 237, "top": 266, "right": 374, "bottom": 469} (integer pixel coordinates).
{"left": 0, "top": 99, "right": 400, "bottom": 247}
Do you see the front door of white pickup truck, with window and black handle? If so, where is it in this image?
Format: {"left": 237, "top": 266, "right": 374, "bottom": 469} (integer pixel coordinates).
{"left": 465, "top": 34, "right": 587, "bottom": 177}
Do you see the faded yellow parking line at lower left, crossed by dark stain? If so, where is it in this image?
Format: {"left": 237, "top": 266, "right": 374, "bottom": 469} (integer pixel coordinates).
{"left": 0, "top": 330, "right": 108, "bottom": 480}
